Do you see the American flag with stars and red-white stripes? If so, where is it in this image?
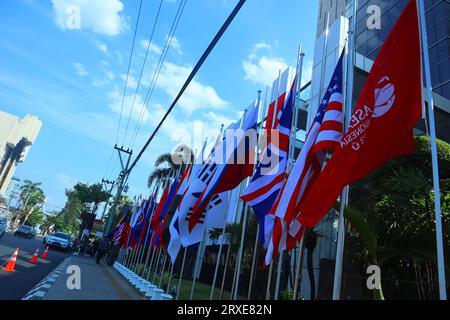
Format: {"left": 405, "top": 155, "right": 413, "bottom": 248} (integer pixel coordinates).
{"left": 265, "top": 53, "right": 344, "bottom": 264}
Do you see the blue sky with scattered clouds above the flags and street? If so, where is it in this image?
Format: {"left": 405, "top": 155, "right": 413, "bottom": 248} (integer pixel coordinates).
{"left": 0, "top": 0, "right": 319, "bottom": 210}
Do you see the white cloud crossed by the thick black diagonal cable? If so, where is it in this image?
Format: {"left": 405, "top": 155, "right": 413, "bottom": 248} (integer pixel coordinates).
{"left": 156, "top": 62, "right": 229, "bottom": 114}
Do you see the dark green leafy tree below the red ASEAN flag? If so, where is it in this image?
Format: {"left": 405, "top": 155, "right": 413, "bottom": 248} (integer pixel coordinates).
{"left": 345, "top": 137, "right": 450, "bottom": 299}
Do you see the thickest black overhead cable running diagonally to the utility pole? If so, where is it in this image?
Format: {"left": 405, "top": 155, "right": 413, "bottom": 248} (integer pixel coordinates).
{"left": 126, "top": 0, "right": 246, "bottom": 175}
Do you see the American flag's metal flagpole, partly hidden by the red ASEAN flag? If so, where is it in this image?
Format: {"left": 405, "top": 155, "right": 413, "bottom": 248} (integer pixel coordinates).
{"left": 333, "top": 0, "right": 358, "bottom": 300}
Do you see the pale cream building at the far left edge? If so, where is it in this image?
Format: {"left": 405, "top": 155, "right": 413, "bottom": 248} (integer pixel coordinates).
{"left": 0, "top": 111, "right": 42, "bottom": 196}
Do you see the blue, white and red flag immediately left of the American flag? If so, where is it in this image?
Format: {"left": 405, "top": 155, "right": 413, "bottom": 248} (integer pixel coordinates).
{"left": 241, "top": 70, "right": 297, "bottom": 244}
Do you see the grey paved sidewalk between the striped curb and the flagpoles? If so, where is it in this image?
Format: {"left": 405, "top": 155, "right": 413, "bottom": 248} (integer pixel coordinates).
{"left": 43, "top": 256, "right": 143, "bottom": 300}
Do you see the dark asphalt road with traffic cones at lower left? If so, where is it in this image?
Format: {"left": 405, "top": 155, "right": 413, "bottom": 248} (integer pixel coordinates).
{"left": 0, "top": 234, "right": 69, "bottom": 300}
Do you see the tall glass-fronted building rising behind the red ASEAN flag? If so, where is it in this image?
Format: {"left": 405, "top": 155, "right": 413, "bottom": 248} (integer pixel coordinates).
{"left": 300, "top": 0, "right": 450, "bottom": 299}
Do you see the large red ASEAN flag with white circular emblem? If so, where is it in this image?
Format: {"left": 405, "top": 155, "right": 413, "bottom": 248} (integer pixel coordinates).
{"left": 298, "top": 0, "right": 422, "bottom": 228}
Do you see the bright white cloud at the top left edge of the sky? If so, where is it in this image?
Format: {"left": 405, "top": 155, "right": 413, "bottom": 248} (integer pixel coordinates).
{"left": 52, "top": 0, "right": 127, "bottom": 36}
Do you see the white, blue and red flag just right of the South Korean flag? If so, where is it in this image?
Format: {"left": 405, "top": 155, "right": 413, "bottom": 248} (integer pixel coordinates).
{"left": 189, "top": 99, "right": 261, "bottom": 230}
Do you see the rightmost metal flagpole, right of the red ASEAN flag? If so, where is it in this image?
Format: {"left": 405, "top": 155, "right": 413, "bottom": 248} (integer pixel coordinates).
{"left": 418, "top": 0, "right": 447, "bottom": 300}
